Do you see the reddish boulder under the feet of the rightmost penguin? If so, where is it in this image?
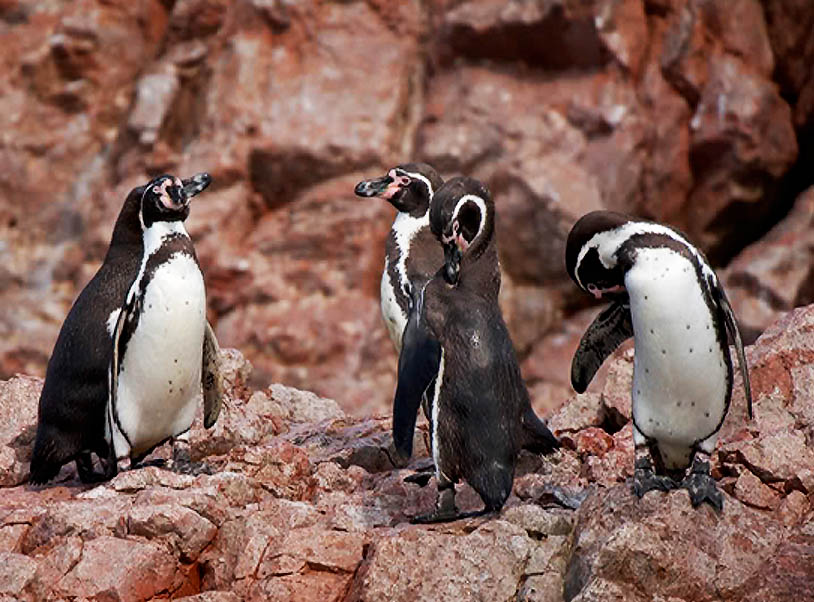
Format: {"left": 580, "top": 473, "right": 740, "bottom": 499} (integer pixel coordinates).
{"left": 564, "top": 485, "right": 802, "bottom": 600}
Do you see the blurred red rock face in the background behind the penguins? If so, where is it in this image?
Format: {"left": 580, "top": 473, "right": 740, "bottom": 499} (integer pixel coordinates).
{"left": 0, "top": 0, "right": 814, "bottom": 414}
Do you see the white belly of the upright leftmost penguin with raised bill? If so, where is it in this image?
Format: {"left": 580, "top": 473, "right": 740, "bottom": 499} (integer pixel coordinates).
{"left": 113, "top": 252, "right": 206, "bottom": 459}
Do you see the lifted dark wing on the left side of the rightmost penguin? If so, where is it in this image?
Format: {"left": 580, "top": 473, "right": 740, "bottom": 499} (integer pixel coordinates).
{"left": 571, "top": 302, "right": 633, "bottom": 393}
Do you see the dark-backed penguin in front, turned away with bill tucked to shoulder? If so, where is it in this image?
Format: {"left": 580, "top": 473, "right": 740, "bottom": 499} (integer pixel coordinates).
{"left": 393, "top": 177, "right": 560, "bottom": 523}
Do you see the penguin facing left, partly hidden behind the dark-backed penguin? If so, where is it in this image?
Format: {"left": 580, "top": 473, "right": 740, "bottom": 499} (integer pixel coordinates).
{"left": 354, "top": 163, "right": 444, "bottom": 353}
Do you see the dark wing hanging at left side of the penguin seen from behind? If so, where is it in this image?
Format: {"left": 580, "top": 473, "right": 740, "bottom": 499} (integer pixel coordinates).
{"left": 393, "top": 290, "right": 441, "bottom": 458}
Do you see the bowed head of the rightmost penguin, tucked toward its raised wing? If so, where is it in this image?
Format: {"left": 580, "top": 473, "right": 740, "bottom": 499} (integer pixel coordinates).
{"left": 565, "top": 211, "right": 633, "bottom": 299}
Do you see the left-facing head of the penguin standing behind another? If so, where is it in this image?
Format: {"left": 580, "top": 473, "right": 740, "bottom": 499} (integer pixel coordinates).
{"left": 354, "top": 163, "right": 443, "bottom": 217}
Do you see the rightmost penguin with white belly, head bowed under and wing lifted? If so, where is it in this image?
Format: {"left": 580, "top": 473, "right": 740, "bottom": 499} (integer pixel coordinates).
{"left": 565, "top": 211, "right": 752, "bottom": 512}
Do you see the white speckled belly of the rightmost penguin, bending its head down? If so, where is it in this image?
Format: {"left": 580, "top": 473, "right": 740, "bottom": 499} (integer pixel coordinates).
{"left": 625, "top": 248, "right": 729, "bottom": 469}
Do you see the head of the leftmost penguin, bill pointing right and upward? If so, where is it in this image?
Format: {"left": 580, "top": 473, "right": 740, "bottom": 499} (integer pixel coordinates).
{"left": 139, "top": 173, "right": 212, "bottom": 228}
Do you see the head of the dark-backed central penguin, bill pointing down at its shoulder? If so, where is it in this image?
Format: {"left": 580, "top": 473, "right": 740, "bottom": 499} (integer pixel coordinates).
{"left": 430, "top": 176, "right": 495, "bottom": 284}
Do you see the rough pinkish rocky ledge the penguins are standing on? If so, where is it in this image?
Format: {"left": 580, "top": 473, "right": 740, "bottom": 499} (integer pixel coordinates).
{"left": 0, "top": 306, "right": 814, "bottom": 602}
